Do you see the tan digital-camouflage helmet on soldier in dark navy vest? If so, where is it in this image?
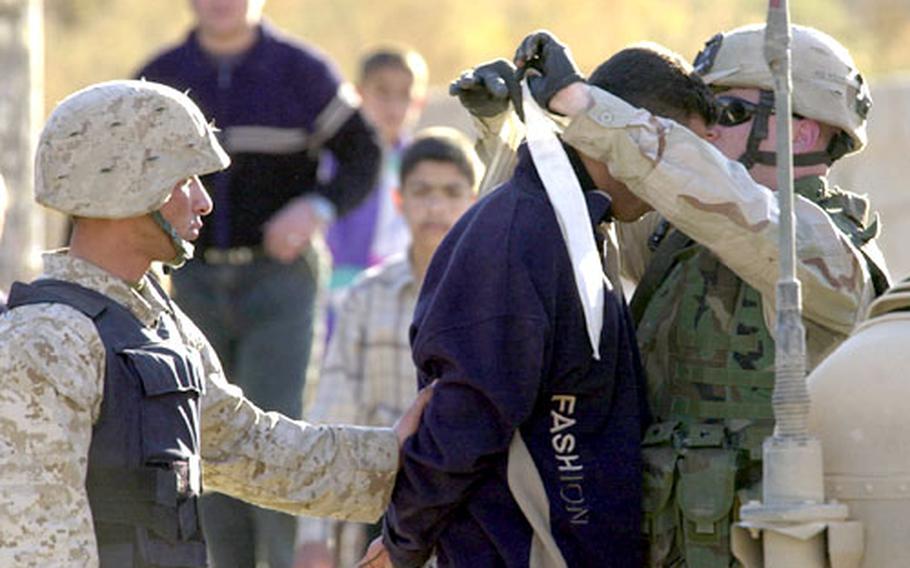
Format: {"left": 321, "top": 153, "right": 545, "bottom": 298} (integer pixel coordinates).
{"left": 35, "top": 77, "right": 230, "bottom": 215}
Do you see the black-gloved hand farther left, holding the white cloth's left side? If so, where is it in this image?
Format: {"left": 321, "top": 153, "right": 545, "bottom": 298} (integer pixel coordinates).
{"left": 449, "top": 59, "right": 524, "bottom": 120}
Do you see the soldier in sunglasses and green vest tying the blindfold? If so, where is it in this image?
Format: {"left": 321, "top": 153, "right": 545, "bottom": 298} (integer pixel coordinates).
{"left": 456, "top": 25, "right": 888, "bottom": 567}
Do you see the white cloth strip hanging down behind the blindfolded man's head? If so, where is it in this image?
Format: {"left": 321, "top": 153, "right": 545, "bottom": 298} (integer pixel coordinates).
{"left": 522, "top": 84, "right": 604, "bottom": 359}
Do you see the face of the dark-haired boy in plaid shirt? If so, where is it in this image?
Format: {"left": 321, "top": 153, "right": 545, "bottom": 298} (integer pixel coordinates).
{"left": 401, "top": 160, "right": 475, "bottom": 250}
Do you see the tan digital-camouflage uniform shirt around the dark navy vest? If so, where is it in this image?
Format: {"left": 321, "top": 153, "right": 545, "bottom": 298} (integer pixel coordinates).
{"left": 0, "top": 251, "right": 398, "bottom": 566}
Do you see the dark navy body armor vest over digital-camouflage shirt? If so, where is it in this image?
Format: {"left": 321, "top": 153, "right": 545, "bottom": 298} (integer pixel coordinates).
{"left": 9, "top": 280, "right": 207, "bottom": 568}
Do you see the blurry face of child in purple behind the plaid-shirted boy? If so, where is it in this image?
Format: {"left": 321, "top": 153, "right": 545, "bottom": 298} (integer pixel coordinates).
{"left": 359, "top": 67, "right": 423, "bottom": 145}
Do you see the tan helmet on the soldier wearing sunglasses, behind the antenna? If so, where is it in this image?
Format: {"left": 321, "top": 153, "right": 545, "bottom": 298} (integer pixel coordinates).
{"left": 695, "top": 24, "right": 872, "bottom": 157}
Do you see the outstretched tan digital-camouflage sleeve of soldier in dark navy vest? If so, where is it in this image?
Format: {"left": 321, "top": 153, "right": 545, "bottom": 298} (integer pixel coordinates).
{"left": 196, "top": 318, "right": 398, "bottom": 522}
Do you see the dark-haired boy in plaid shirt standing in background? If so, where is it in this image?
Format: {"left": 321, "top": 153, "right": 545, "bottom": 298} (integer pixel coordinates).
{"left": 301, "top": 127, "right": 482, "bottom": 565}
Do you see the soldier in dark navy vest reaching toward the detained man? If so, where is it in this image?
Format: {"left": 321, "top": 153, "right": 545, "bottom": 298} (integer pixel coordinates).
{"left": 0, "top": 81, "right": 427, "bottom": 567}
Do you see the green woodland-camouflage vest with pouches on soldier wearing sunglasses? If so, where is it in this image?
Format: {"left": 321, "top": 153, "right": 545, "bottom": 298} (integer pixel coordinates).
{"left": 631, "top": 177, "right": 887, "bottom": 567}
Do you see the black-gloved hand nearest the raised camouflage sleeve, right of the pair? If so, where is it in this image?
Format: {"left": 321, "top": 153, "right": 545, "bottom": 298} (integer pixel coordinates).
{"left": 515, "top": 30, "right": 585, "bottom": 110}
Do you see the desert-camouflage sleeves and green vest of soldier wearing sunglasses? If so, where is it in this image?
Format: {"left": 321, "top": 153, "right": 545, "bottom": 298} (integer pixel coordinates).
{"left": 565, "top": 89, "right": 887, "bottom": 567}
